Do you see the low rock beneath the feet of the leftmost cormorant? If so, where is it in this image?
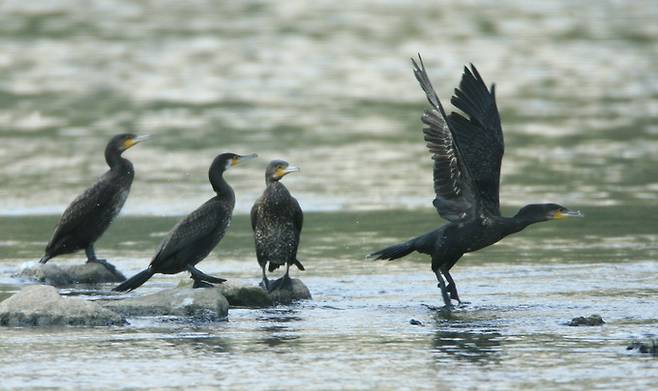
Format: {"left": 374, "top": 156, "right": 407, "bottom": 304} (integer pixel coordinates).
{"left": 12, "top": 262, "right": 126, "bottom": 286}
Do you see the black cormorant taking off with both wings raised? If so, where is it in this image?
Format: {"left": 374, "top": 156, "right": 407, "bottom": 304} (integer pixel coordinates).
{"left": 370, "top": 55, "right": 582, "bottom": 306}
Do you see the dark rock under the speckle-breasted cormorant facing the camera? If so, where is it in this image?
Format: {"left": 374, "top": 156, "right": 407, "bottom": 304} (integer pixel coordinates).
{"left": 178, "top": 278, "right": 312, "bottom": 308}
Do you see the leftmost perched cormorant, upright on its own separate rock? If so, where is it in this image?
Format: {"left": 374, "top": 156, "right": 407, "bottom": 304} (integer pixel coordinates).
{"left": 39, "top": 134, "right": 149, "bottom": 270}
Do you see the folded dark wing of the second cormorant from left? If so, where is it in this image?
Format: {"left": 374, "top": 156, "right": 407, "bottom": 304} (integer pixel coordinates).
{"left": 151, "top": 198, "right": 231, "bottom": 265}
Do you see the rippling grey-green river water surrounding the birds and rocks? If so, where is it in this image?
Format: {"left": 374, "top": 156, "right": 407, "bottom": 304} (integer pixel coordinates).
{"left": 0, "top": 0, "right": 658, "bottom": 389}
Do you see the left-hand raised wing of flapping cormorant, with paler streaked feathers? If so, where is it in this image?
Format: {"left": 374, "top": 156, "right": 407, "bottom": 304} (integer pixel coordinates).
{"left": 411, "top": 55, "right": 477, "bottom": 221}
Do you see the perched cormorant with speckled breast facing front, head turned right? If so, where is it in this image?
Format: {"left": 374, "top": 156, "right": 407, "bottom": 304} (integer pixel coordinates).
{"left": 251, "top": 160, "right": 304, "bottom": 291}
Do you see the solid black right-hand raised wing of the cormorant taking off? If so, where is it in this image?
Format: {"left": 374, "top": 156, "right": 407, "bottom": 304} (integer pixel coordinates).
{"left": 448, "top": 64, "right": 505, "bottom": 216}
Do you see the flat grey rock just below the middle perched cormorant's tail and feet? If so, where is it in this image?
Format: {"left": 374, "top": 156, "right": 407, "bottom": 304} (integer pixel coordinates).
{"left": 101, "top": 288, "right": 229, "bottom": 321}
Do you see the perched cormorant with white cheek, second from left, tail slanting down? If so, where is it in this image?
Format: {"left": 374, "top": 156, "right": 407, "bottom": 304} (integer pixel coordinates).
{"left": 113, "top": 153, "right": 258, "bottom": 292}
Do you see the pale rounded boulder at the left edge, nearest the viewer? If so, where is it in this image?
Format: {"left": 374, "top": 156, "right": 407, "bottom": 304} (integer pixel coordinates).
{"left": 0, "top": 285, "right": 125, "bottom": 326}
